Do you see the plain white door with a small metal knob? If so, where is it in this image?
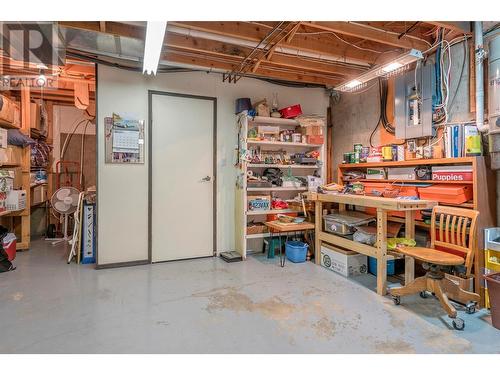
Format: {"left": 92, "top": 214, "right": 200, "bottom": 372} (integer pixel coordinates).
{"left": 150, "top": 93, "right": 215, "bottom": 262}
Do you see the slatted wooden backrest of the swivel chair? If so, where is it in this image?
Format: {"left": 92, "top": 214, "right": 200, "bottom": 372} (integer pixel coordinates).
{"left": 431, "top": 206, "right": 479, "bottom": 276}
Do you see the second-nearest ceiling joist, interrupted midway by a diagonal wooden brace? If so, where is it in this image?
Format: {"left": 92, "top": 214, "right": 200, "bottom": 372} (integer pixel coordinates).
{"left": 168, "top": 21, "right": 380, "bottom": 64}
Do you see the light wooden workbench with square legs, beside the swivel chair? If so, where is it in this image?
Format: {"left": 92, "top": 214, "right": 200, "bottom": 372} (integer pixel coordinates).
{"left": 306, "top": 193, "right": 437, "bottom": 295}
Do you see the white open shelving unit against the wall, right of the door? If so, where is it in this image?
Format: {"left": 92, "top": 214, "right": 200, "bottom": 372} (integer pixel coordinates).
{"left": 235, "top": 116, "right": 326, "bottom": 259}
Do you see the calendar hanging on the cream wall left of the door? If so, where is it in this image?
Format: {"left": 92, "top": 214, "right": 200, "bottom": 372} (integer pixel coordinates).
{"left": 104, "top": 113, "right": 144, "bottom": 164}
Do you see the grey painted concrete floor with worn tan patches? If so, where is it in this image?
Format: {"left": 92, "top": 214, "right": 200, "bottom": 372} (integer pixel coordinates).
{"left": 0, "top": 241, "right": 500, "bottom": 353}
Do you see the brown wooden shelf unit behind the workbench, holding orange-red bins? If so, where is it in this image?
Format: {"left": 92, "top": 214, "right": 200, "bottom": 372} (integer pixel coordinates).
{"left": 338, "top": 156, "right": 496, "bottom": 304}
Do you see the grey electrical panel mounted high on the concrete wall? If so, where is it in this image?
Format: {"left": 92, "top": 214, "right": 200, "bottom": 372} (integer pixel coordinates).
{"left": 394, "top": 64, "right": 433, "bottom": 139}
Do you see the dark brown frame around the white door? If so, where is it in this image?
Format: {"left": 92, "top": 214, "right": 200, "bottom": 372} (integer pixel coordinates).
{"left": 148, "top": 90, "right": 218, "bottom": 263}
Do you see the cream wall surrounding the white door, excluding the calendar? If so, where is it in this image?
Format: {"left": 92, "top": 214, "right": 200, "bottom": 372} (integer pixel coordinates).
{"left": 97, "top": 65, "right": 328, "bottom": 265}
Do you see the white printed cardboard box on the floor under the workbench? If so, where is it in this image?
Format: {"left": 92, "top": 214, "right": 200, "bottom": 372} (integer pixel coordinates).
{"left": 321, "top": 244, "right": 368, "bottom": 277}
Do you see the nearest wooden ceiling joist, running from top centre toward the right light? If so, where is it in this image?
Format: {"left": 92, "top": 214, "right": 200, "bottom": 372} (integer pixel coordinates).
{"left": 302, "top": 22, "right": 429, "bottom": 51}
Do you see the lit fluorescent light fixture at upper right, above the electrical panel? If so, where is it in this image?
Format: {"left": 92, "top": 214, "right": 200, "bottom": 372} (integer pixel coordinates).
{"left": 335, "top": 49, "right": 424, "bottom": 91}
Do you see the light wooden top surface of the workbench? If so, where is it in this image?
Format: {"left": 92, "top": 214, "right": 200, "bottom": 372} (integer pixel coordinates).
{"left": 305, "top": 193, "right": 437, "bottom": 211}
